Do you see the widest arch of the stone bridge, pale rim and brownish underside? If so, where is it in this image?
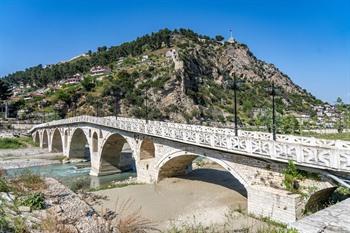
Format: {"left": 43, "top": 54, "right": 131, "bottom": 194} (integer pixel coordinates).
{"left": 155, "top": 151, "right": 249, "bottom": 191}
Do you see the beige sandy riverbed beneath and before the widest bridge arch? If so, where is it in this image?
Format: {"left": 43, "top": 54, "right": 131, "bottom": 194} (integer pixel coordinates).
{"left": 94, "top": 169, "right": 246, "bottom": 230}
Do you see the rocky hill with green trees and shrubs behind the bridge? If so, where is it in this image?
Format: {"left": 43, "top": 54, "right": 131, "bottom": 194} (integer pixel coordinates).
{"left": 5, "top": 29, "right": 322, "bottom": 132}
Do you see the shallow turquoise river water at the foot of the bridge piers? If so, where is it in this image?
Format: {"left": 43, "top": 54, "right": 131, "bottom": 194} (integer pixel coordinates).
{"left": 6, "top": 163, "right": 136, "bottom": 189}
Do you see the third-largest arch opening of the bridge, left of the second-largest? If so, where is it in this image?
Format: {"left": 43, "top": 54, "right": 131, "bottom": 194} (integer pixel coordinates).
{"left": 68, "top": 128, "right": 90, "bottom": 160}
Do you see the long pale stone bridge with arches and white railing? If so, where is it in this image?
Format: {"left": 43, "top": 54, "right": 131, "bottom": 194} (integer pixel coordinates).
{"left": 30, "top": 116, "right": 350, "bottom": 223}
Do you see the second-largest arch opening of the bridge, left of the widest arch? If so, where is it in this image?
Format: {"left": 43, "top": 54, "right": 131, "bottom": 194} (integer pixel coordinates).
{"left": 100, "top": 133, "right": 135, "bottom": 175}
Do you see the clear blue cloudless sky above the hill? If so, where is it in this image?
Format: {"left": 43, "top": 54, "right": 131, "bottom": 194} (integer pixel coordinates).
{"left": 0, "top": 0, "right": 350, "bottom": 103}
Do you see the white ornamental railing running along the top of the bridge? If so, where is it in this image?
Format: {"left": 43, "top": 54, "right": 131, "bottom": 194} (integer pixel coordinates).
{"left": 30, "top": 116, "right": 350, "bottom": 172}
